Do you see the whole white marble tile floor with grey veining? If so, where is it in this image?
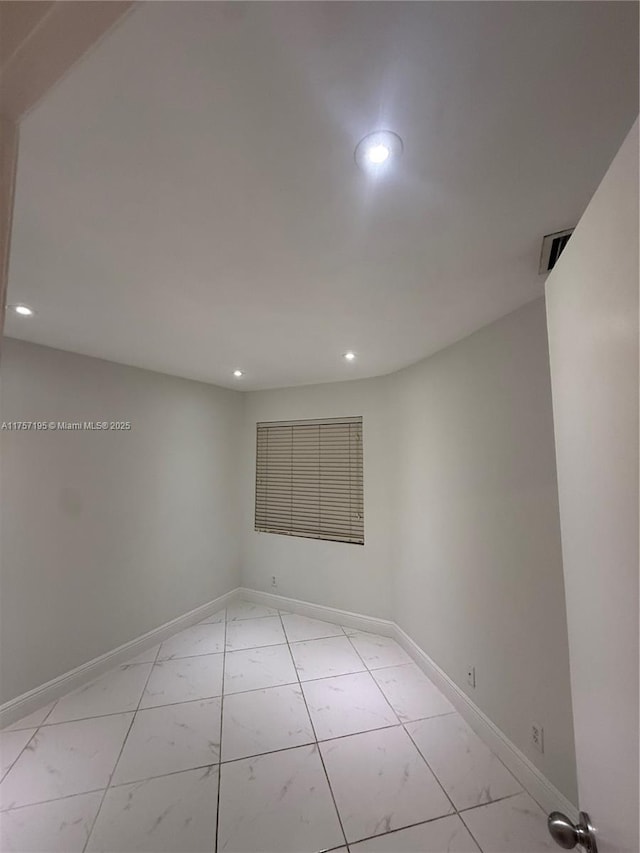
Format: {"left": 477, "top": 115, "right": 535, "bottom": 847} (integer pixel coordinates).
{"left": 0, "top": 601, "right": 553, "bottom": 853}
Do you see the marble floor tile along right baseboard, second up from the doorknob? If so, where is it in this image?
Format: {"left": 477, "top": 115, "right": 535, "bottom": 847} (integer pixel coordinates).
{"left": 406, "top": 714, "right": 522, "bottom": 809}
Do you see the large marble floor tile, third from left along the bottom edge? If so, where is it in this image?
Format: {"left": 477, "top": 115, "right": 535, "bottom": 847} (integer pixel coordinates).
{"left": 218, "top": 745, "right": 344, "bottom": 853}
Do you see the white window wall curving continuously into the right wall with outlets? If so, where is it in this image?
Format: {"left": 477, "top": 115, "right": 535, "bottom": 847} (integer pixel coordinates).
{"left": 242, "top": 299, "right": 576, "bottom": 802}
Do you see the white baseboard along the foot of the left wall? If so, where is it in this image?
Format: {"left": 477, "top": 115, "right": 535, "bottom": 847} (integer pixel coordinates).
{"left": 0, "top": 589, "right": 238, "bottom": 728}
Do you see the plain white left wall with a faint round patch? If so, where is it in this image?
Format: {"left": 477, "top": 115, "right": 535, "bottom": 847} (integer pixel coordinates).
{"left": 0, "top": 339, "right": 242, "bottom": 703}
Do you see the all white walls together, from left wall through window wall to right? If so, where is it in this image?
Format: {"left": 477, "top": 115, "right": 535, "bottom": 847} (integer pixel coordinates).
{"left": 0, "top": 300, "right": 576, "bottom": 801}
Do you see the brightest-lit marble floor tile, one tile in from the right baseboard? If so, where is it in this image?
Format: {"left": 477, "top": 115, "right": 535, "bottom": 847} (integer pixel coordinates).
{"left": 302, "top": 672, "right": 398, "bottom": 740}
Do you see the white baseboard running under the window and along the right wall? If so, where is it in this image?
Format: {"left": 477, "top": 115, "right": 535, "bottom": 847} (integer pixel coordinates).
{"left": 238, "top": 588, "right": 578, "bottom": 822}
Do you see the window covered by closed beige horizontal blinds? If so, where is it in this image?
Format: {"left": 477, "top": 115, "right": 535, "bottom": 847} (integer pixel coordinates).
{"left": 255, "top": 418, "right": 364, "bottom": 545}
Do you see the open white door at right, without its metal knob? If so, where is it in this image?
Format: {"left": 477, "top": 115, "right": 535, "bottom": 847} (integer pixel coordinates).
{"left": 547, "top": 121, "right": 640, "bottom": 853}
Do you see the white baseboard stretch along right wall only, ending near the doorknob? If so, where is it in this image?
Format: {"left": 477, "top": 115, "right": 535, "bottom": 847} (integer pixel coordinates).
{"left": 395, "top": 625, "right": 578, "bottom": 822}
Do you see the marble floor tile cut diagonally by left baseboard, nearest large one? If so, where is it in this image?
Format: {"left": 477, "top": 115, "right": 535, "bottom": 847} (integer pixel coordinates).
{"left": 47, "top": 663, "right": 153, "bottom": 725}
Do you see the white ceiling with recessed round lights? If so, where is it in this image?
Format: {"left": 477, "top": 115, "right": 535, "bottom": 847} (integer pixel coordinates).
{"left": 5, "top": 2, "right": 638, "bottom": 389}
